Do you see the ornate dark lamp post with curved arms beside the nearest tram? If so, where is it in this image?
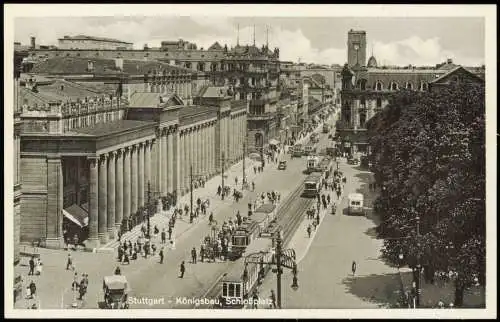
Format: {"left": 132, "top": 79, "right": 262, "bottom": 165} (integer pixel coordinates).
{"left": 243, "top": 230, "right": 299, "bottom": 309}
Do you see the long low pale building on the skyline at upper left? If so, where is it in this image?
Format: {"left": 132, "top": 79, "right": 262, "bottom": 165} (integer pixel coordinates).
{"left": 58, "top": 35, "right": 133, "bottom": 50}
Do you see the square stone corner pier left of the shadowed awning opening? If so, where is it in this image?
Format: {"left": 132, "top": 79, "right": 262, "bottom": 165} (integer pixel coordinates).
{"left": 45, "top": 156, "right": 63, "bottom": 249}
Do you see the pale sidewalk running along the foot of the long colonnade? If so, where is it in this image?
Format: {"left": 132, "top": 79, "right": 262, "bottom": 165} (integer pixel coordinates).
{"left": 97, "top": 158, "right": 265, "bottom": 252}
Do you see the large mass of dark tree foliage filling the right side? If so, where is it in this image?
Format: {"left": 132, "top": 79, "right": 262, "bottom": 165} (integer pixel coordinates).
{"left": 368, "top": 84, "right": 486, "bottom": 306}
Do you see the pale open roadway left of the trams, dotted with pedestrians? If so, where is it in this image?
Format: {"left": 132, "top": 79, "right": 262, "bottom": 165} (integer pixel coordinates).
{"left": 16, "top": 115, "right": 333, "bottom": 308}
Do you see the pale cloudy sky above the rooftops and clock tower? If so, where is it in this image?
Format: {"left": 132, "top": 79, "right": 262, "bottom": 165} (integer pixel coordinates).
{"left": 14, "top": 15, "right": 485, "bottom": 66}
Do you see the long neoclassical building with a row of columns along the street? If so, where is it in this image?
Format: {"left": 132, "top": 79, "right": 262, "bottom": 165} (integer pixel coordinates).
{"left": 18, "top": 71, "right": 247, "bottom": 248}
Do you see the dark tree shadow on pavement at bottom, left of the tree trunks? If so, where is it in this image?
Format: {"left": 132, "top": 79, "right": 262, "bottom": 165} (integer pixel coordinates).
{"left": 342, "top": 273, "right": 401, "bottom": 308}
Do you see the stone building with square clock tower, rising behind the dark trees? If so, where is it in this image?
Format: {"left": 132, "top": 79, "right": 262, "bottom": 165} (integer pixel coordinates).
{"left": 337, "top": 30, "right": 484, "bottom": 153}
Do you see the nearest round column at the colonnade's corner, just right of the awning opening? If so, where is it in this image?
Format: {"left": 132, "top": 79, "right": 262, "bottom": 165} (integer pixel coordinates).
{"left": 86, "top": 158, "right": 99, "bottom": 249}
